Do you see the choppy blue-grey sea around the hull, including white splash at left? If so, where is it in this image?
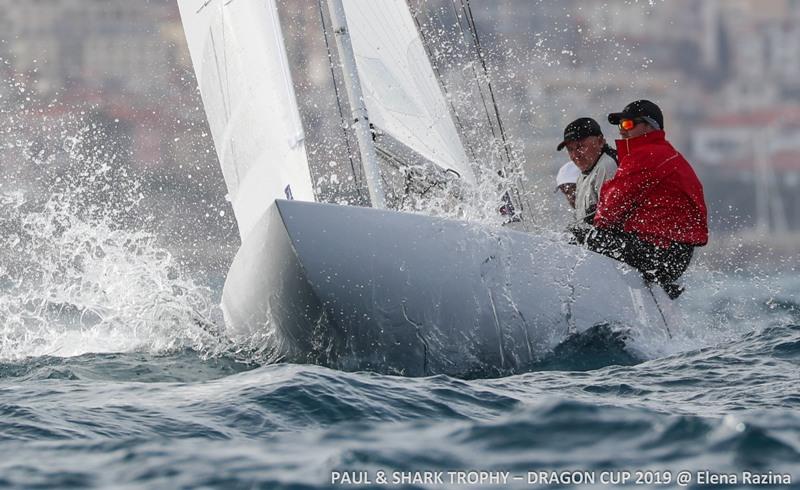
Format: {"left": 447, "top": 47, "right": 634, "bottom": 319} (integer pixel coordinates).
{"left": 0, "top": 189, "right": 800, "bottom": 488}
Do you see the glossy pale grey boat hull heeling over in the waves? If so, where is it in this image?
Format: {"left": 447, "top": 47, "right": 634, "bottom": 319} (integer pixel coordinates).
{"left": 222, "top": 201, "right": 668, "bottom": 376}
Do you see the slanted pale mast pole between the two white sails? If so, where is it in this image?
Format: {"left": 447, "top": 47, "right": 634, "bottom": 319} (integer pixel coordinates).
{"left": 328, "top": 0, "right": 386, "bottom": 209}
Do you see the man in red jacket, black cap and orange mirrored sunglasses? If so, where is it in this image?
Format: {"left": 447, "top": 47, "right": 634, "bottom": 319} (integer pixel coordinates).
{"left": 578, "top": 100, "right": 708, "bottom": 299}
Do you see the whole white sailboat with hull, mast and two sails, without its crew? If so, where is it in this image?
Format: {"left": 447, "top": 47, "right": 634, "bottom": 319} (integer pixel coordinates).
{"left": 178, "top": 0, "right": 671, "bottom": 376}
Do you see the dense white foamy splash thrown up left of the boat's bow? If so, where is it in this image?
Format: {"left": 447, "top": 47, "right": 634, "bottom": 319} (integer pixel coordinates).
{"left": 0, "top": 192, "right": 221, "bottom": 360}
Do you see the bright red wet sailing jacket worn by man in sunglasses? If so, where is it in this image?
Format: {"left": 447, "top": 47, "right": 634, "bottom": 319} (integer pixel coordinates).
{"left": 594, "top": 131, "right": 708, "bottom": 248}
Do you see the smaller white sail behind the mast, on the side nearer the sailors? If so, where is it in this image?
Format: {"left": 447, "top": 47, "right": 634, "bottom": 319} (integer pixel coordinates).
{"left": 343, "top": 0, "right": 475, "bottom": 183}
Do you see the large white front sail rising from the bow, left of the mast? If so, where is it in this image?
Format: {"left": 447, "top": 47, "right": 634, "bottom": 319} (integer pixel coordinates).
{"left": 178, "top": 0, "right": 314, "bottom": 241}
